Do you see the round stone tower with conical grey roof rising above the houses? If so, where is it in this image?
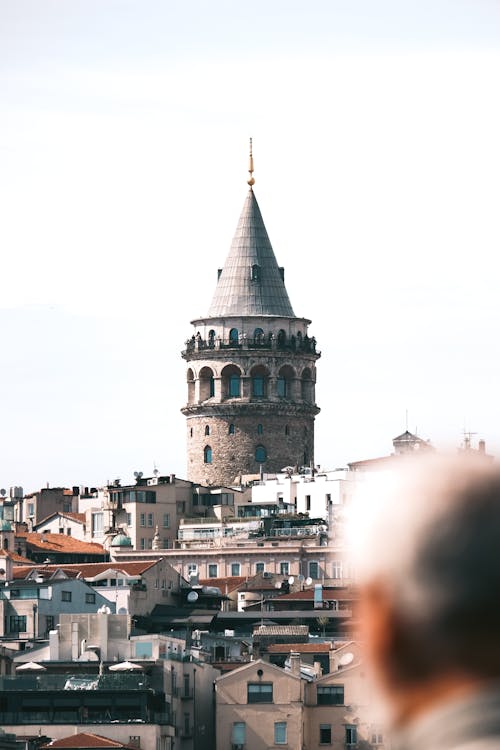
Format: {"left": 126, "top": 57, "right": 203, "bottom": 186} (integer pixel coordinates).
{"left": 182, "top": 147, "right": 320, "bottom": 486}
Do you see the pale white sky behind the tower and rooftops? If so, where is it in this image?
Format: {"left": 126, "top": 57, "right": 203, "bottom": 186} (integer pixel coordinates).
{"left": 0, "top": 0, "right": 500, "bottom": 491}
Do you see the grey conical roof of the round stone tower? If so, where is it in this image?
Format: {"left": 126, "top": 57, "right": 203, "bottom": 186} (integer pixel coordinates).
{"left": 208, "top": 188, "right": 295, "bottom": 318}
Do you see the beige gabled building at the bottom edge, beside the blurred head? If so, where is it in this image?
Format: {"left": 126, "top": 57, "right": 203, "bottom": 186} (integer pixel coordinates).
{"left": 216, "top": 642, "right": 389, "bottom": 750}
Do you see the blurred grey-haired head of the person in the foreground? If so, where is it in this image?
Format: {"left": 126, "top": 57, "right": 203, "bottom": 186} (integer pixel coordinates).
{"left": 354, "top": 454, "right": 500, "bottom": 715}
